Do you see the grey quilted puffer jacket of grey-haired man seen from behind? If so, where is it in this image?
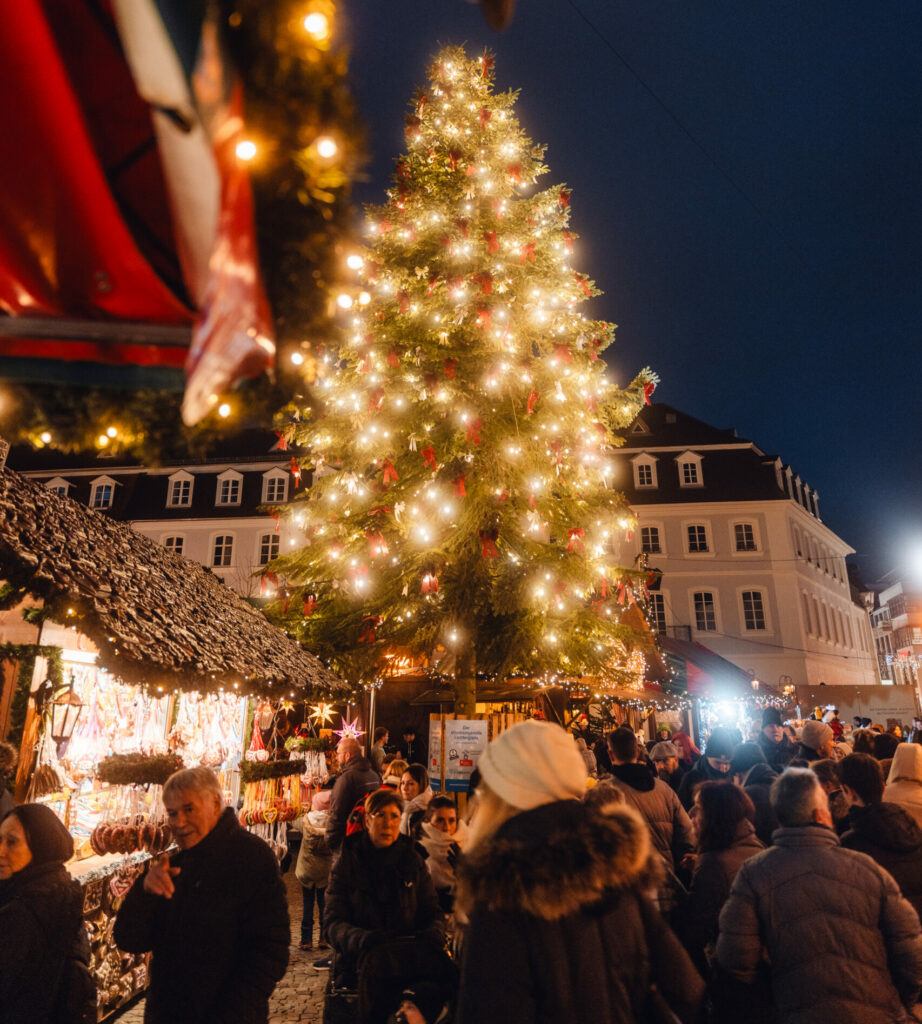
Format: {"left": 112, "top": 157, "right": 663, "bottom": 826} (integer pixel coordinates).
{"left": 717, "top": 825, "right": 922, "bottom": 1024}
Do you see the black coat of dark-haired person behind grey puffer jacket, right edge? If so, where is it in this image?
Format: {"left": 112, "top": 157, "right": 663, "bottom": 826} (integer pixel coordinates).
{"left": 841, "top": 804, "right": 922, "bottom": 918}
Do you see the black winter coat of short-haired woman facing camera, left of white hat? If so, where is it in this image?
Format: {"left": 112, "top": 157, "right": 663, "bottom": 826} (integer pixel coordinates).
{"left": 324, "top": 831, "right": 443, "bottom": 987}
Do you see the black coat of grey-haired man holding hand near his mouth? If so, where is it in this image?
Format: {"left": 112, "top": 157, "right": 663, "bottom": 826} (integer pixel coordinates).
{"left": 115, "top": 807, "right": 291, "bottom": 1024}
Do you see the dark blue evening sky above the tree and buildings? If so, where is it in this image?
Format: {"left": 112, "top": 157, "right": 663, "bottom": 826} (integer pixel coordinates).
{"left": 349, "top": 0, "right": 922, "bottom": 580}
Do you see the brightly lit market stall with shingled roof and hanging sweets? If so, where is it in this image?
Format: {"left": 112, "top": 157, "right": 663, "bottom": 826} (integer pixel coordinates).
{"left": 0, "top": 469, "right": 347, "bottom": 1019}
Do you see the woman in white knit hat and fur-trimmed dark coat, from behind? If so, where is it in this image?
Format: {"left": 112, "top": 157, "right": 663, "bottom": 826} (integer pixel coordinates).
{"left": 456, "top": 721, "right": 704, "bottom": 1024}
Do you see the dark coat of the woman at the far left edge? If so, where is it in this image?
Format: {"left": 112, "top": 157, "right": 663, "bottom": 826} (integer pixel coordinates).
{"left": 0, "top": 862, "right": 89, "bottom": 1024}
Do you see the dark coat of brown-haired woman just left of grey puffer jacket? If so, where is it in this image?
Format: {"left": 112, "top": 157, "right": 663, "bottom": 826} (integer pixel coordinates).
{"left": 679, "top": 821, "right": 765, "bottom": 971}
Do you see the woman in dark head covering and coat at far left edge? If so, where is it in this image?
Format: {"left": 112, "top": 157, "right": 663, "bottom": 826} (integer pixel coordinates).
{"left": 0, "top": 804, "right": 96, "bottom": 1024}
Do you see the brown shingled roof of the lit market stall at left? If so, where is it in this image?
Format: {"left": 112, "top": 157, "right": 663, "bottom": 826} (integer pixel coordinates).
{"left": 0, "top": 468, "right": 348, "bottom": 692}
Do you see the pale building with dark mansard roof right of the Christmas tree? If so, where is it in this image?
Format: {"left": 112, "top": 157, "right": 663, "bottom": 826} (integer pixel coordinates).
{"left": 615, "top": 403, "right": 880, "bottom": 689}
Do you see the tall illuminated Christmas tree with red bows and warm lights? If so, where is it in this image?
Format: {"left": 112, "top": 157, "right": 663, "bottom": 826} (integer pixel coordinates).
{"left": 273, "top": 48, "right": 656, "bottom": 714}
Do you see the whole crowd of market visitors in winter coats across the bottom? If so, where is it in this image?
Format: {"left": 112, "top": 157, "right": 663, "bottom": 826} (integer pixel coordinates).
{"left": 0, "top": 708, "right": 922, "bottom": 1024}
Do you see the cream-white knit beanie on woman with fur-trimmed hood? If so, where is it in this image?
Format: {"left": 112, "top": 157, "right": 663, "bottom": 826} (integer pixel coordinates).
{"left": 477, "top": 719, "right": 588, "bottom": 811}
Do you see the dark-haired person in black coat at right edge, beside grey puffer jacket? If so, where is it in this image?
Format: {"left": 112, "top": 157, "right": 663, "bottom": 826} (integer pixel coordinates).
{"left": 838, "top": 754, "right": 922, "bottom": 916}
